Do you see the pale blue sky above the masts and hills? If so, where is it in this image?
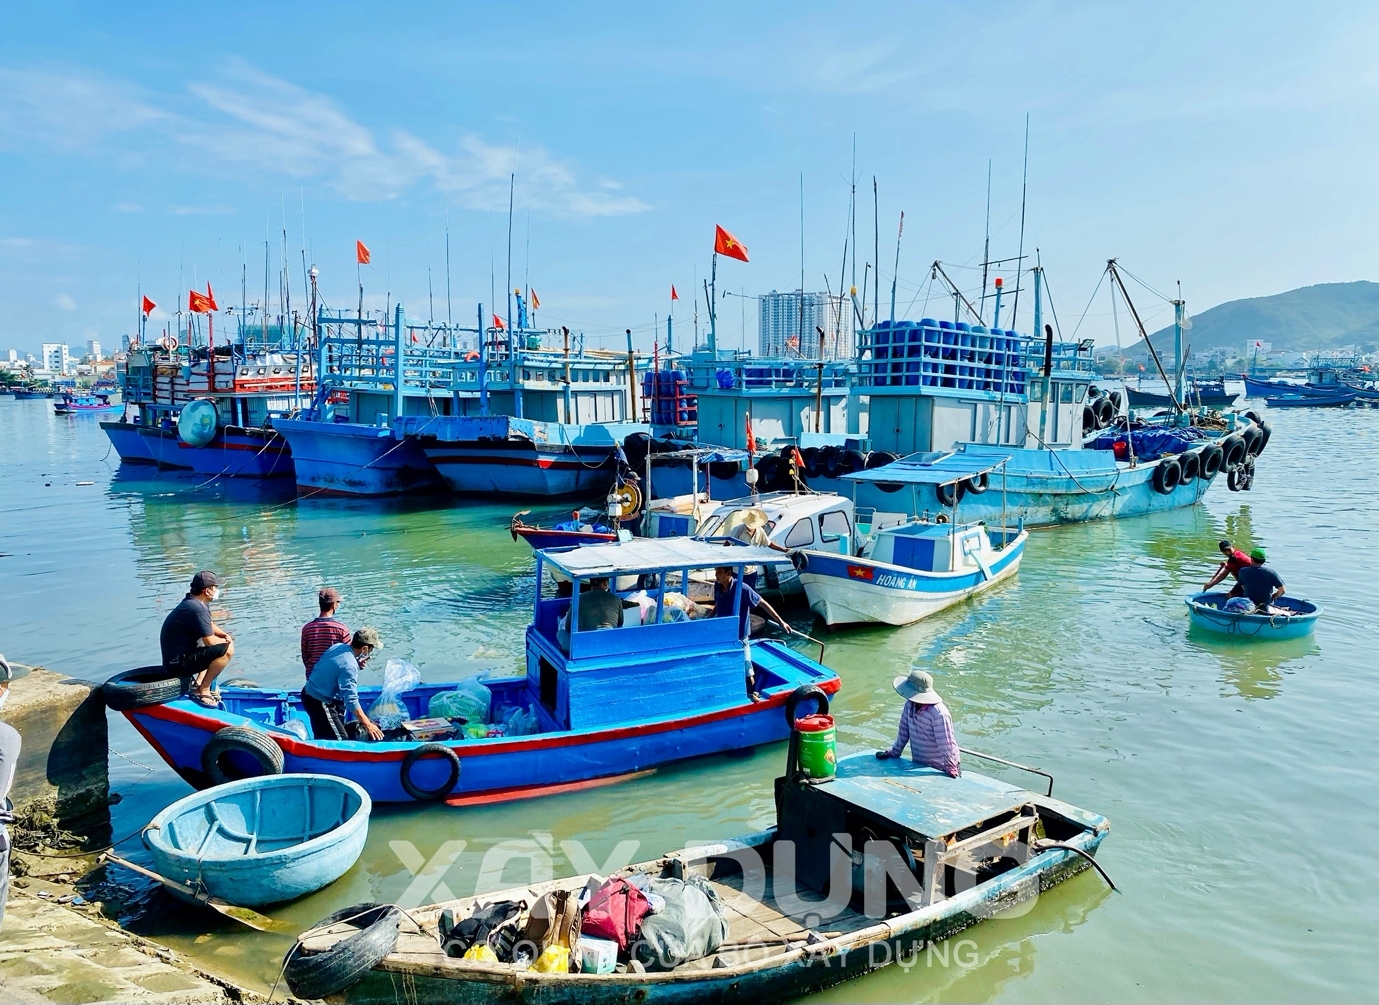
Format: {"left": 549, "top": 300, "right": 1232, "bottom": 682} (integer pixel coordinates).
{"left": 0, "top": 3, "right": 1379, "bottom": 352}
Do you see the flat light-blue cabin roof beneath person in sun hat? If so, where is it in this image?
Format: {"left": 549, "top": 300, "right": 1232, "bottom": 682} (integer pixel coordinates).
{"left": 827, "top": 753, "right": 1033, "bottom": 838}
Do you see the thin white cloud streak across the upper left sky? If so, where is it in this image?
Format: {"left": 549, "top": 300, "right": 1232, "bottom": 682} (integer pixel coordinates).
{"left": 0, "top": 61, "right": 650, "bottom": 216}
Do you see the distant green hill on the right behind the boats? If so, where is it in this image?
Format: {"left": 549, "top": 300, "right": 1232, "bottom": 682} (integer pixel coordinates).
{"left": 1136, "top": 281, "right": 1379, "bottom": 353}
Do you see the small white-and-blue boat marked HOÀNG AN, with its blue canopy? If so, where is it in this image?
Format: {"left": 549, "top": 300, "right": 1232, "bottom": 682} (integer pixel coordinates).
{"left": 794, "top": 455, "right": 1029, "bottom": 627}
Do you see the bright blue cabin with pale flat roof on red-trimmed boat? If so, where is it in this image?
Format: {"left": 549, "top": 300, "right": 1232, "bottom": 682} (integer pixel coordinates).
{"left": 527, "top": 538, "right": 816, "bottom": 729}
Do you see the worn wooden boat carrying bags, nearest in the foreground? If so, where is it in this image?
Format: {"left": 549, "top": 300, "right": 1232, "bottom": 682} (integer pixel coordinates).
{"left": 302, "top": 751, "right": 1110, "bottom": 1005}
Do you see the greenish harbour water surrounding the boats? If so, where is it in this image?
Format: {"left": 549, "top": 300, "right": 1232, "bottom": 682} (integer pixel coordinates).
{"left": 0, "top": 397, "right": 1379, "bottom": 1002}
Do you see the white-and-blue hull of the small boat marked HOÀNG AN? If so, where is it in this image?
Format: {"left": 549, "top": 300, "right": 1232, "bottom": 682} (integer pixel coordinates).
{"left": 800, "top": 534, "right": 1029, "bottom": 627}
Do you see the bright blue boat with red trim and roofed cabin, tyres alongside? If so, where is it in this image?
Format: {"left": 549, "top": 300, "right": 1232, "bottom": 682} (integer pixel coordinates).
{"left": 115, "top": 538, "right": 840, "bottom": 805}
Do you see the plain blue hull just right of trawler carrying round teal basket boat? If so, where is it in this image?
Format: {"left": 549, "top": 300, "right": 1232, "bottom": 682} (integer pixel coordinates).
{"left": 273, "top": 419, "right": 444, "bottom": 496}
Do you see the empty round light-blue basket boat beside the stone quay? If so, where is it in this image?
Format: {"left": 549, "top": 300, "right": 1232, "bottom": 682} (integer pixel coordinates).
{"left": 143, "top": 775, "right": 372, "bottom": 907}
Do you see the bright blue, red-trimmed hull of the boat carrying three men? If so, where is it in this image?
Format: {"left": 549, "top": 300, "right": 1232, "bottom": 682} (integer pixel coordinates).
{"left": 124, "top": 641, "right": 840, "bottom": 804}
